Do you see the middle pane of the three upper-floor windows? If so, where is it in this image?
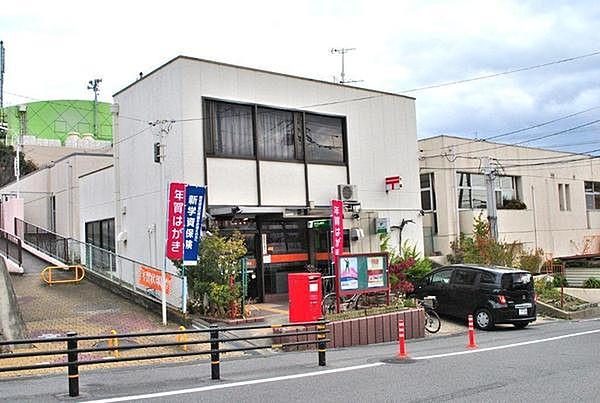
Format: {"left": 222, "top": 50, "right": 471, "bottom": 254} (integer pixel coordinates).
{"left": 256, "top": 108, "right": 303, "bottom": 160}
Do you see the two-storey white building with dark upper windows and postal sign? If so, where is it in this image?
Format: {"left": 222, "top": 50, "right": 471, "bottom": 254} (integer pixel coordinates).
{"left": 111, "top": 56, "right": 423, "bottom": 300}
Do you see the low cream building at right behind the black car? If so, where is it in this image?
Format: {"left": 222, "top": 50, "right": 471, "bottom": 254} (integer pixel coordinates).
{"left": 419, "top": 136, "right": 600, "bottom": 257}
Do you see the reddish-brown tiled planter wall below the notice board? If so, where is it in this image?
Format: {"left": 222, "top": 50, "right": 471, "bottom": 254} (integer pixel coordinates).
{"left": 273, "top": 308, "right": 425, "bottom": 351}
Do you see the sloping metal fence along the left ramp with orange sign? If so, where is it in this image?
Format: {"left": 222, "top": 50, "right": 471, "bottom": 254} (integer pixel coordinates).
{"left": 15, "top": 218, "right": 187, "bottom": 312}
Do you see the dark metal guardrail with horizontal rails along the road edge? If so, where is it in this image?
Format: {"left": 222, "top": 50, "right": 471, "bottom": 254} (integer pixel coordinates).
{"left": 0, "top": 320, "right": 330, "bottom": 397}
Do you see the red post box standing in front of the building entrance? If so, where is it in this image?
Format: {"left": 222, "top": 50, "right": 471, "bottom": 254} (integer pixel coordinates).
{"left": 288, "top": 273, "right": 323, "bottom": 322}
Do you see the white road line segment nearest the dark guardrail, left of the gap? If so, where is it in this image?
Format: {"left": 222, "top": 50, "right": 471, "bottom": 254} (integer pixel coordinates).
{"left": 82, "top": 362, "right": 385, "bottom": 403}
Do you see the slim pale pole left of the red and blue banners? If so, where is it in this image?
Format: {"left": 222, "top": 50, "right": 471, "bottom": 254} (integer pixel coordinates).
{"left": 149, "top": 120, "right": 175, "bottom": 326}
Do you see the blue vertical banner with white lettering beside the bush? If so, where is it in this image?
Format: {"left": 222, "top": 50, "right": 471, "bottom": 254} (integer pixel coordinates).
{"left": 183, "top": 185, "right": 206, "bottom": 266}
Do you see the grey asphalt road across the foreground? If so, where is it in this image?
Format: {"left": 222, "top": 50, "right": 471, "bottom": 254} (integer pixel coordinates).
{"left": 0, "top": 320, "right": 600, "bottom": 402}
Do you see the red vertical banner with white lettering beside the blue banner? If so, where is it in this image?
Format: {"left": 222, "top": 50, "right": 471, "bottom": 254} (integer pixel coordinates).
{"left": 166, "top": 182, "right": 185, "bottom": 260}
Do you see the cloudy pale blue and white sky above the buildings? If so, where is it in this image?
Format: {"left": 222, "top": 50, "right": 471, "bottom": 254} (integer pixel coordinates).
{"left": 0, "top": 0, "right": 600, "bottom": 155}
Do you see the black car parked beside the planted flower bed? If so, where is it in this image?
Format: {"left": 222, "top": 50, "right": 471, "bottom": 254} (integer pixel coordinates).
{"left": 414, "top": 264, "right": 536, "bottom": 330}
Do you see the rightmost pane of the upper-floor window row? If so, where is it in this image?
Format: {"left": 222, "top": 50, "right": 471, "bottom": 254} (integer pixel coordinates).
{"left": 306, "top": 113, "right": 344, "bottom": 163}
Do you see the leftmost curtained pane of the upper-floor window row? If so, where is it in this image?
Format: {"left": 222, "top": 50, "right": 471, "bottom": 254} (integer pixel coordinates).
{"left": 204, "top": 101, "right": 254, "bottom": 157}
